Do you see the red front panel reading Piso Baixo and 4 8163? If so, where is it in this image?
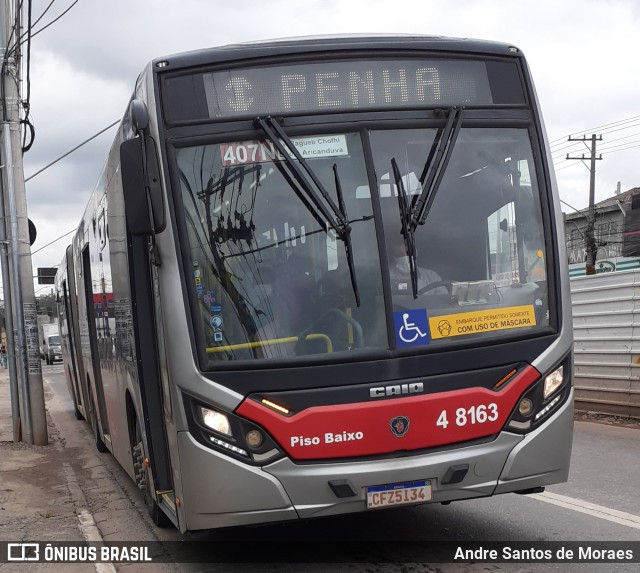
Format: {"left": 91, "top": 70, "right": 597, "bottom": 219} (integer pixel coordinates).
{"left": 236, "top": 366, "right": 540, "bottom": 460}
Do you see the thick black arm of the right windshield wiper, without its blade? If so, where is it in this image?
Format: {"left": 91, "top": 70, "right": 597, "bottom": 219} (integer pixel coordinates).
{"left": 410, "top": 107, "right": 464, "bottom": 232}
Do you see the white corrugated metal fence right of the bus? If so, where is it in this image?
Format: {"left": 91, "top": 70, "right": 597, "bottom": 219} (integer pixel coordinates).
{"left": 571, "top": 270, "right": 640, "bottom": 418}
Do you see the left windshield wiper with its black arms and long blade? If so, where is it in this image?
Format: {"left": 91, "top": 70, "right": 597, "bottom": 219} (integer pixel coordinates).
{"left": 255, "top": 116, "right": 360, "bottom": 306}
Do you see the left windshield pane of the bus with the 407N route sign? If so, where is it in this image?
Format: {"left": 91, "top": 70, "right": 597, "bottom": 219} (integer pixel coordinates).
{"left": 177, "top": 133, "right": 386, "bottom": 360}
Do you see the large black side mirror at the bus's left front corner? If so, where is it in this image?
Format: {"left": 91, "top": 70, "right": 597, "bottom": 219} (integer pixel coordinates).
{"left": 120, "top": 133, "right": 165, "bottom": 235}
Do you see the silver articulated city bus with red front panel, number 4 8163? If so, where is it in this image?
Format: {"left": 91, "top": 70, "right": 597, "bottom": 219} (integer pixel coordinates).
{"left": 56, "top": 36, "right": 573, "bottom": 532}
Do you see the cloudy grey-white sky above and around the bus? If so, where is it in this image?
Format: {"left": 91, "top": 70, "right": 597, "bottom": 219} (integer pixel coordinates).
{"left": 12, "top": 0, "right": 640, "bottom": 296}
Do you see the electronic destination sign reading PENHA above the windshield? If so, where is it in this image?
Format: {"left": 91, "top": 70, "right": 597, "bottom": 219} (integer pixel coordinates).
{"left": 163, "top": 59, "right": 524, "bottom": 122}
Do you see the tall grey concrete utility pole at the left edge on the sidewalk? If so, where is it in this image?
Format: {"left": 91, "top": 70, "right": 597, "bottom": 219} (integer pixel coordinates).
{"left": 0, "top": 0, "right": 49, "bottom": 446}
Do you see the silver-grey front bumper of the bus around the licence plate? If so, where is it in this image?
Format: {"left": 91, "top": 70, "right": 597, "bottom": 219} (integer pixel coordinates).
{"left": 178, "top": 392, "right": 573, "bottom": 530}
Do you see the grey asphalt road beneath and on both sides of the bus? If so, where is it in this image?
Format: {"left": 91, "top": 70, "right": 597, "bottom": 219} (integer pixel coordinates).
{"left": 43, "top": 365, "right": 640, "bottom": 573}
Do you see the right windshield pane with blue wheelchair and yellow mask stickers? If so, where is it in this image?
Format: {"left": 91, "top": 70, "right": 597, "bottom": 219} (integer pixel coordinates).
{"left": 371, "top": 128, "right": 549, "bottom": 346}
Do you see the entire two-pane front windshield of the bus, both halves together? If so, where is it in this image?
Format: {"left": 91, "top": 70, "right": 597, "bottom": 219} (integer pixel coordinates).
{"left": 176, "top": 126, "right": 549, "bottom": 366}
